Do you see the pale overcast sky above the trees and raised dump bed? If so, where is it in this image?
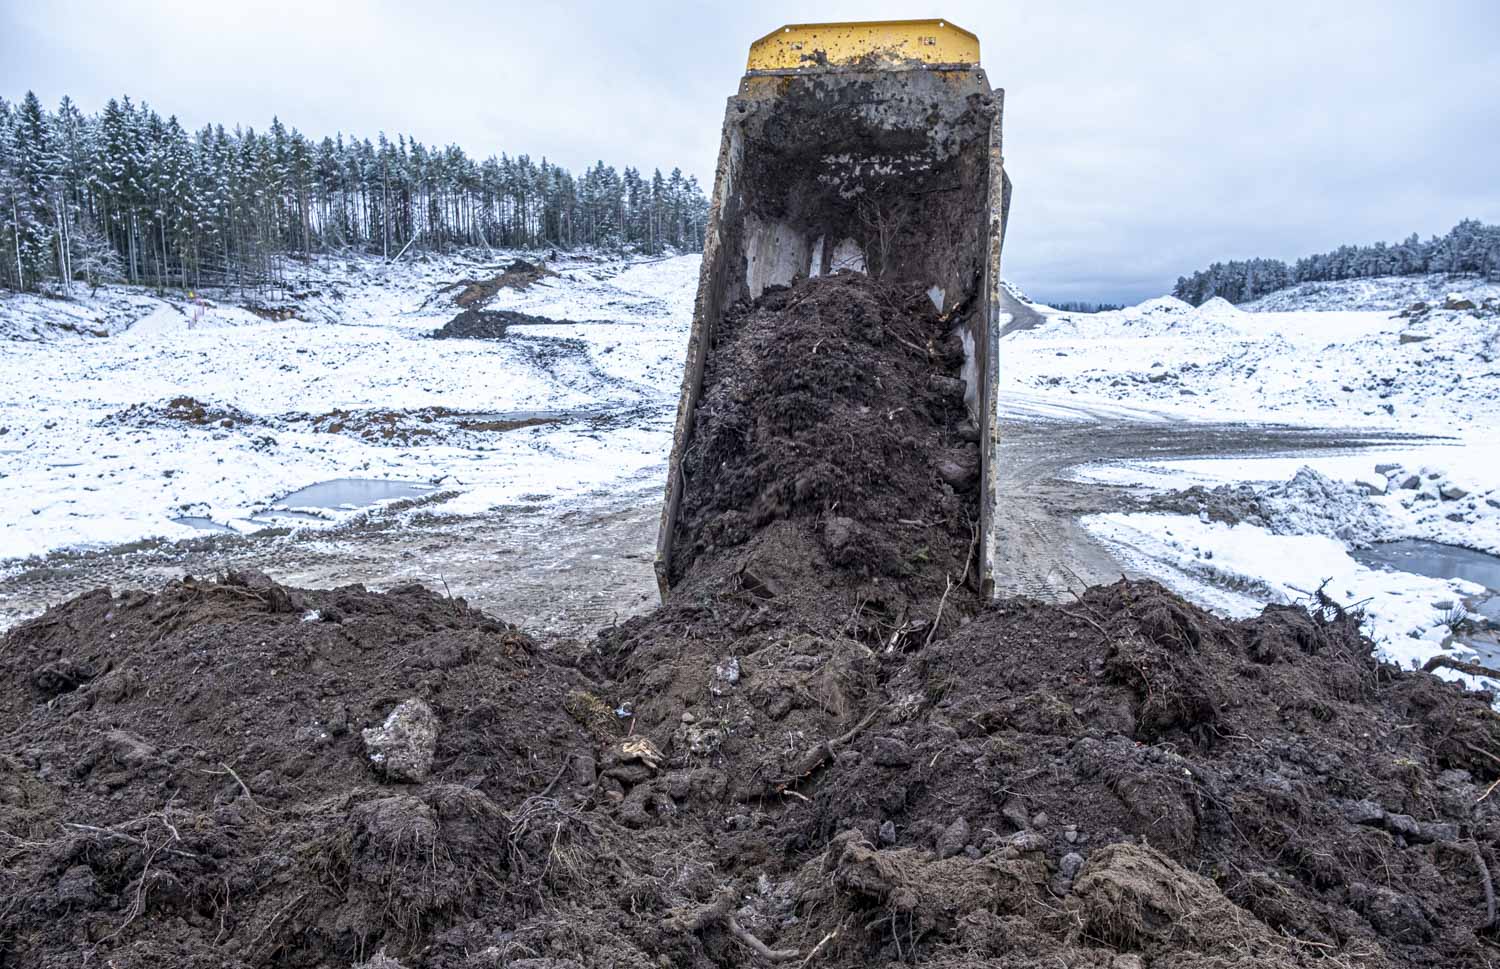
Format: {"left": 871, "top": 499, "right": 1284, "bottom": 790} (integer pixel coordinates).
{"left": 0, "top": 0, "right": 1500, "bottom": 302}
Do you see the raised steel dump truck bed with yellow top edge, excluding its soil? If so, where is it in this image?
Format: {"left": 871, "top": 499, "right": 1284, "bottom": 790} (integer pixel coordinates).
{"left": 656, "top": 21, "right": 1010, "bottom": 599}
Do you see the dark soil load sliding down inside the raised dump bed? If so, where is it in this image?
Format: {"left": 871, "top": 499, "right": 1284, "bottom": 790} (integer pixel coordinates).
{"left": 672, "top": 273, "right": 980, "bottom": 627}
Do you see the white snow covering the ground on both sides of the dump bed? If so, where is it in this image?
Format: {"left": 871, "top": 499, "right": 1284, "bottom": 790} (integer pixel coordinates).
{"left": 0, "top": 254, "right": 1500, "bottom": 699}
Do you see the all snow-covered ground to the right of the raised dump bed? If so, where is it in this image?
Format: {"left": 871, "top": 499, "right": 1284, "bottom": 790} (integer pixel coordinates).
{"left": 1002, "top": 278, "right": 1500, "bottom": 696}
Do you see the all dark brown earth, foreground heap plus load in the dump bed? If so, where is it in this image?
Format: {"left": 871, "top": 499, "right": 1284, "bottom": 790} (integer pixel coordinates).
{"left": 0, "top": 276, "right": 1500, "bottom": 969}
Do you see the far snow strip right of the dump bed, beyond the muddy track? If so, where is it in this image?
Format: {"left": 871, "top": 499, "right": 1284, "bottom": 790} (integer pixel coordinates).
{"left": 1001, "top": 280, "right": 1500, "bottom": 434}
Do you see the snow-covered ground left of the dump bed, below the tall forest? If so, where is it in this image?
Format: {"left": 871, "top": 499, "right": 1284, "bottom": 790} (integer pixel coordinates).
{"left": 0, "top": 254, "right": 699, "bottom": 567}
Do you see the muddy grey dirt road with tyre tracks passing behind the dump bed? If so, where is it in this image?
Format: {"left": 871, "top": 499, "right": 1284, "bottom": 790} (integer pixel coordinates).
{"left": 0, "top": 401, "right": 1428, "bottom": 636}
